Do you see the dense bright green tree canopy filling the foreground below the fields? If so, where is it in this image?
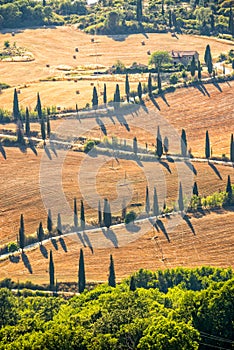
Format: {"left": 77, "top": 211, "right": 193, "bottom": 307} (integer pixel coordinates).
{"left": 0, "top": 267, "right": 234, "bottom": 350}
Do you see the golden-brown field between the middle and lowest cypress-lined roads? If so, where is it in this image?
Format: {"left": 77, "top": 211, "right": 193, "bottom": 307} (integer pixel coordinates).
{"left": 0, "top": 147, "right": 233, "bottom": 244}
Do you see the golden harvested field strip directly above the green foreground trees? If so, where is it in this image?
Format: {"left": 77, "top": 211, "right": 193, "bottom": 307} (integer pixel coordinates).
{"left": 0, "top": 211, "right": 234, "bottom": 283}
